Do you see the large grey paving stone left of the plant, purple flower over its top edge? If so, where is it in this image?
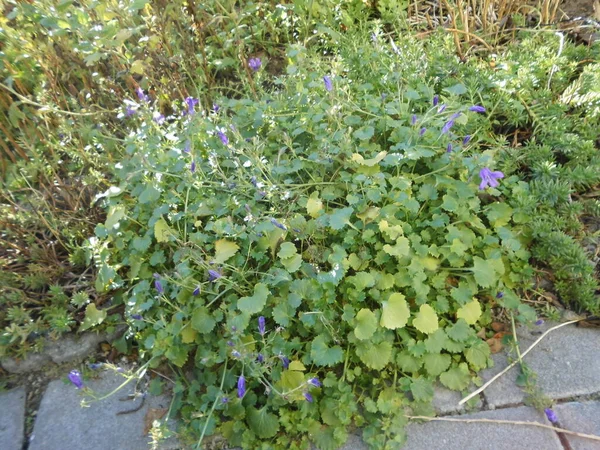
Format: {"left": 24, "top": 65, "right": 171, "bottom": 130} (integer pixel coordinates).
{"left": 29, "top": 372, "right": 181, "bottom": 450}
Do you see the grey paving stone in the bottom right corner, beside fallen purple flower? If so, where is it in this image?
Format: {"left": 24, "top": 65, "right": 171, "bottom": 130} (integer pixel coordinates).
{"left": 553, "top": 402, "right": 600, "bottom": 450}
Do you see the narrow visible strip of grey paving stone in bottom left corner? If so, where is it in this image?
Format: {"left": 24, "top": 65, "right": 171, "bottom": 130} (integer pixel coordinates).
{"left": 0, "top": 388, "right": 25, "bottom": 450}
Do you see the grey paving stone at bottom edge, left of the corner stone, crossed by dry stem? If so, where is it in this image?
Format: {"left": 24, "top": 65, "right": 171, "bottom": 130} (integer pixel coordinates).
{"left": 402, "top": 406, "right": 562, "bottom": 450}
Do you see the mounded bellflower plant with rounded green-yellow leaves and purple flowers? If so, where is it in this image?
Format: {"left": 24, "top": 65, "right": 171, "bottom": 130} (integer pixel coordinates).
{"left": 89, "top": 32, "right": 535, "bottom": 448}
